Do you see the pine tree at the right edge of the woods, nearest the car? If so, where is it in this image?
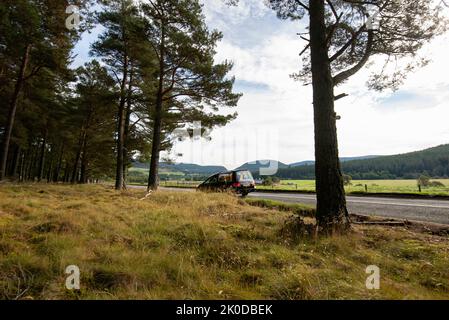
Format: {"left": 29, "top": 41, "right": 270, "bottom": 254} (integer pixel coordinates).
{"left": 142, "top": 0, "right": 240, "bottom": 190}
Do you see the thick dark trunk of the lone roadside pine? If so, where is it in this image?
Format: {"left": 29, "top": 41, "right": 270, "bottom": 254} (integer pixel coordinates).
{"left": 310, "top": 0, "right": 350, "bottom": 235}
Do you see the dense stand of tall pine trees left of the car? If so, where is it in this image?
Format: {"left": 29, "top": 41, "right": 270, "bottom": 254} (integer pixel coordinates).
{"left": 0, "top": 0, "right": 240, "bottom": 189}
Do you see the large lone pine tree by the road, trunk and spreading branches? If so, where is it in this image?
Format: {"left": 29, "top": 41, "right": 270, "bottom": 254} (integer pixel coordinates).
{"left": 228, "top": 0, "right": 447, "bottom": 234}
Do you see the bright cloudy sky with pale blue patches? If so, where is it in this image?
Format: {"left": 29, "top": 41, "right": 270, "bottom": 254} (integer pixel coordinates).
{"left": 75, "top": 0, "right": 449, "bottom": 169}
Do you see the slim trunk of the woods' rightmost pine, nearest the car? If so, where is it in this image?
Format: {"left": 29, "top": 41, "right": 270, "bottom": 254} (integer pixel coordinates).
{"left": 148, "top": 21, "right": 165, "bottom": 191}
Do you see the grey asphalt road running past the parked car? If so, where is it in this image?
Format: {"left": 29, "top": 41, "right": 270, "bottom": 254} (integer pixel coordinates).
{"left": 151, "top": 188, "right": 449, "bottom": 225}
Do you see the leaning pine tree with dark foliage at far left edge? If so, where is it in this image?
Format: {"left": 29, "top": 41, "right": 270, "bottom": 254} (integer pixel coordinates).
{"left": 0, "top": 0, "right": 89, "bottom": 181}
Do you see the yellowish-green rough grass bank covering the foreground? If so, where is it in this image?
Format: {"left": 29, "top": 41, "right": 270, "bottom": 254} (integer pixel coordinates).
{"left": 0, "top": 185, "right": 449, "bottom": 299}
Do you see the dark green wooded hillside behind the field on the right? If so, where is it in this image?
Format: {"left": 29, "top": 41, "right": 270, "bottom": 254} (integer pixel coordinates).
{"left": 254, "top": 145, "right": 449, "bottom": 180}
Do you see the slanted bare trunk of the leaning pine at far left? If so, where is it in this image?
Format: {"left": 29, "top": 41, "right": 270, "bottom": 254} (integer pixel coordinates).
{"left": 0, "top": 44, "right": 31, "bottom": 181}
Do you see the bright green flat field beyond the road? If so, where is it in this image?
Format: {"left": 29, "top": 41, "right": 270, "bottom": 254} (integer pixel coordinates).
{"left": 161, "top": 179, "right": 449, "bottom": 196}
